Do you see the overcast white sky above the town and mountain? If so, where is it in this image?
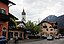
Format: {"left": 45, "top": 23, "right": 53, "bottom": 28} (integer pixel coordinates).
{"left": 9, "top": 0, "right": 64, "bottom": 22}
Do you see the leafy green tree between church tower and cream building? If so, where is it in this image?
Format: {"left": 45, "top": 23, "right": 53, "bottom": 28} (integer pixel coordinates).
{"left": 25, "top": 21, "right": 42, "bottom": 35}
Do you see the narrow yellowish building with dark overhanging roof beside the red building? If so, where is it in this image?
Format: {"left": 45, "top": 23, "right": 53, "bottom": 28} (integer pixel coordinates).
{"left": 8, "top": 13, "right": 18, "bottom": 39}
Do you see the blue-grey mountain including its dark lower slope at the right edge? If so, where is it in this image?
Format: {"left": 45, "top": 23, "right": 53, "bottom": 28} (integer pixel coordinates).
{"left": 43, "top": 15, "right": 64, "bottom": 33}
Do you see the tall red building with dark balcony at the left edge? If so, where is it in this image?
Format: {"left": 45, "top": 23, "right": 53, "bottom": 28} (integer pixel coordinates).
{"left": 0, "top": 0, "right": 8, "bottom": 39}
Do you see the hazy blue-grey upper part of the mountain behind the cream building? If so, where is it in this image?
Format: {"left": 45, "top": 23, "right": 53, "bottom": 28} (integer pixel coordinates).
{"left": 43, "top": 15, "right": 64, "bottom": 28}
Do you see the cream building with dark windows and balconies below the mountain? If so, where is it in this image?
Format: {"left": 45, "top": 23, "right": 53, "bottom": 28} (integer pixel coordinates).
{"left": 40, "top": 21, "right": 58, "bottom": 37}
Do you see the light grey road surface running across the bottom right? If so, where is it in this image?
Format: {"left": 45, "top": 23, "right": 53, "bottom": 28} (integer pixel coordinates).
{"left": 18, "top": 39, "right": 64, "bottom": 44}
